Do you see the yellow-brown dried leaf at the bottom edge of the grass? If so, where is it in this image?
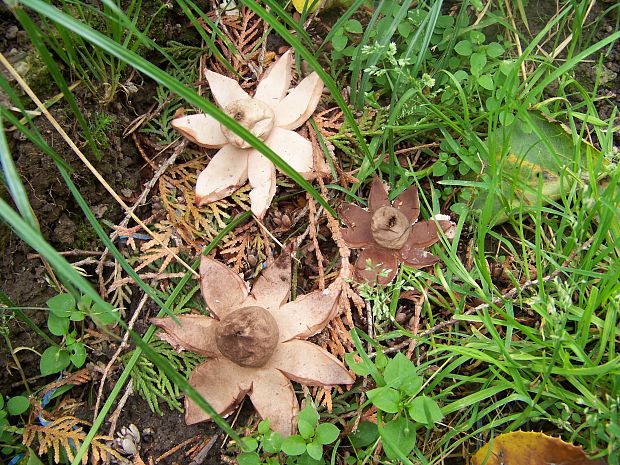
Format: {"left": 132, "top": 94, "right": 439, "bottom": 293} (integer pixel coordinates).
{"left": 470, "top": 431, "right": 605, "bottom": 465}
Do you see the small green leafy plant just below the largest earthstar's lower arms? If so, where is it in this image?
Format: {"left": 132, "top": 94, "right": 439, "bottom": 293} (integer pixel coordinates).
{"left": 237, "top": 402, "right": 340, "bottom": 465}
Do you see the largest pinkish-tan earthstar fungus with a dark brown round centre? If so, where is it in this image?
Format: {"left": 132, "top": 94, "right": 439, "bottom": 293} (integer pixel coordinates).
{"left": 151, "top": 252, "right": 353, "bottom": 436}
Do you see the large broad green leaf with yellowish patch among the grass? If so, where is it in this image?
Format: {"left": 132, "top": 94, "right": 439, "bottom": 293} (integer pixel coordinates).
{"left": 472, "top": 110, "right": 606, "bottom": 224}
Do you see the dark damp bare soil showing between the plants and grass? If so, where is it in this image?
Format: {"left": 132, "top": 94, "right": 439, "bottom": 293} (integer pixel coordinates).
{"left": 0, "top": 0, "right": 620, "bottom": 465}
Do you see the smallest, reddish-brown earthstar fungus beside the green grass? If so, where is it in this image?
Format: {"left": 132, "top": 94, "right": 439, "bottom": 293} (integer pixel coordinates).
{"left": 340, "top": 177, "right": 454, "bottom": 286}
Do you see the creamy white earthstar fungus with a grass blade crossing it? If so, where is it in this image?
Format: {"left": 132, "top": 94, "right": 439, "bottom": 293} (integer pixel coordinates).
{"left": 171, "top": 50, "right": 323, "bottom": 219}
